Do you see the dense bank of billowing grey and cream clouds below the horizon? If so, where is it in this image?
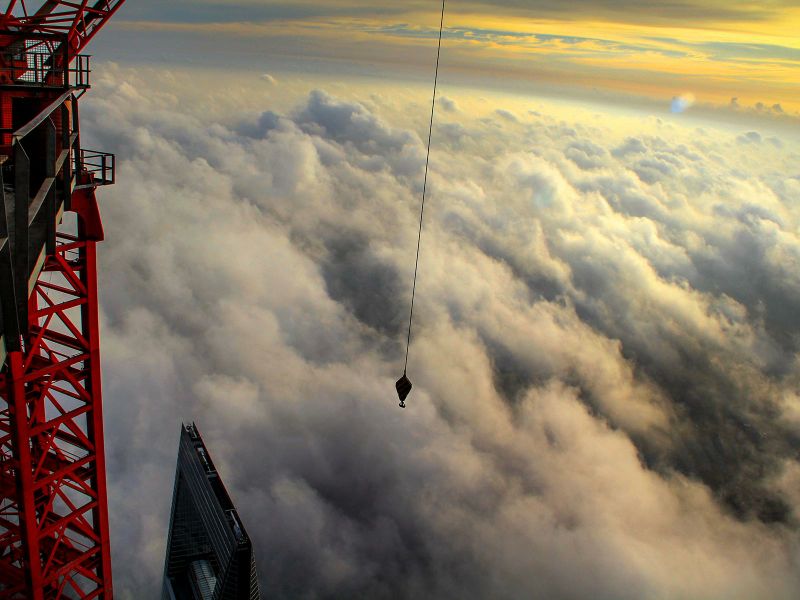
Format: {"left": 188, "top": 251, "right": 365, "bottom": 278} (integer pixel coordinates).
{"left": 83, "top": 70, "right": 800, "bottom": 599}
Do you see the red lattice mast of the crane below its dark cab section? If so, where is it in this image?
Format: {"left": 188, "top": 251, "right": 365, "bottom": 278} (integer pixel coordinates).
{"left": 0, "top": 213, "right": 111, "bottom": 600}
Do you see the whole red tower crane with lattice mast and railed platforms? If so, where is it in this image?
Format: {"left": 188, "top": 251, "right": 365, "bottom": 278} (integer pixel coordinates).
{"left": 0, "top": 0, "right": 124, "bottom": 600}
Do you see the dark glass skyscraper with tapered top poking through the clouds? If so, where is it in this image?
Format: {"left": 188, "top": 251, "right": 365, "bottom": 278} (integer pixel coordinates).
{"left": 162, "top": 423, "right": 261, "bottom": 600}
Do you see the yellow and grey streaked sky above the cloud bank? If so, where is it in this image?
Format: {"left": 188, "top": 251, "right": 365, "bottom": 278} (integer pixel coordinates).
{"left": 101, "top": 0, "right": 800, "bottom": 117}
